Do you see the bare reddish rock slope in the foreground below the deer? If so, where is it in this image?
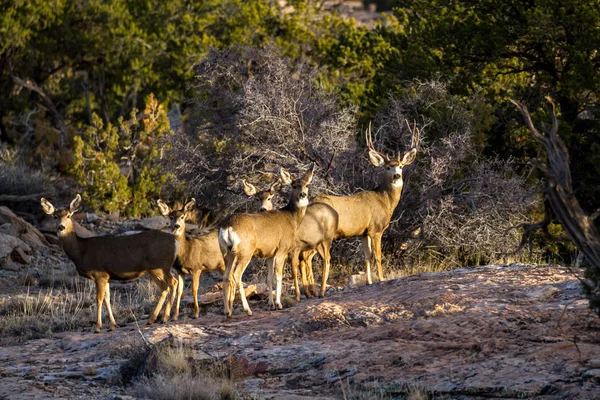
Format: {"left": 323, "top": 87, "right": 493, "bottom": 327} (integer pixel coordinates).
{"left": 0, "top": 264, "right": 600, "bottom": 399}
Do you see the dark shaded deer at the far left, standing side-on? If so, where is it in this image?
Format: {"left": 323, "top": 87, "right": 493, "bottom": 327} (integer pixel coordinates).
{"left": 41, "top": 195, "right": 178, "bottom": 332}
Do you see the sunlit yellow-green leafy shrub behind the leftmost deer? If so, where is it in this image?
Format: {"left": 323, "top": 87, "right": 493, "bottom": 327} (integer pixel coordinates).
{"left": 69, "top": 95, "right": 171, "bottom": 216}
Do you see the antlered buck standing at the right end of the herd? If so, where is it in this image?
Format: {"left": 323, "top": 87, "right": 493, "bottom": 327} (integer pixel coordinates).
{"left": 314, "top": 122, "right": 420, "bottom": 296}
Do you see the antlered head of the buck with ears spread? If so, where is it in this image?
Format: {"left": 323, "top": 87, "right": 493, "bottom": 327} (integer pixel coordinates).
{"left": 366, "top": 122, "right": 421, "bottom": 187}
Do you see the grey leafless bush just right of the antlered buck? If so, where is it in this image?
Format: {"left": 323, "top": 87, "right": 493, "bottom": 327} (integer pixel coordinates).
{"left": 376, "top": 81, "right": 539, "bottom": 265}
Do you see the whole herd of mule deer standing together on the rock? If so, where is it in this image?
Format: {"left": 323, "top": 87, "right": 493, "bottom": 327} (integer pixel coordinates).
{"left": 41, "top": 124, "right": 420, "bottom": 332}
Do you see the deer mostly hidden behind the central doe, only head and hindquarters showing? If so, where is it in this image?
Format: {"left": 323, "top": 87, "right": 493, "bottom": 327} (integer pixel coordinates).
{"left": 242, "top": 180, "right": 338, "bottom": 300}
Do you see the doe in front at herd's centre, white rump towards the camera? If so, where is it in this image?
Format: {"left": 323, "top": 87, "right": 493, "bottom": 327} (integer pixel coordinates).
{"left": 219, "top": 165, "right": 314, "bottom": 317}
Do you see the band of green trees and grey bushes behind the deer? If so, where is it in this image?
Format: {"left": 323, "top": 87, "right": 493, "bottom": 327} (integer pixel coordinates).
{"left": 0, "top": 0, "right": 600, "bottom": 276}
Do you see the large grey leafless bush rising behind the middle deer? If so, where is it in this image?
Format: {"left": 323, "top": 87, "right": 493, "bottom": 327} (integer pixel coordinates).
{"left": 167, "top": 47, "right": 357, "bottom": 211}
